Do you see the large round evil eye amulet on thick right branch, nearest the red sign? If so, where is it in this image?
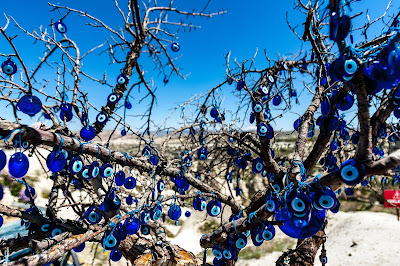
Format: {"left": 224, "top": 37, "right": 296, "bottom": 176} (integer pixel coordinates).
{"left": 340, "top": 159, "right": 367, "bottom": 186}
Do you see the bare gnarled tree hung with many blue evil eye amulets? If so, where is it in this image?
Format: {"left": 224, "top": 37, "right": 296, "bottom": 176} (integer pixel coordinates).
{"left": 0, "top": 0, "right": 400, "bottom": 265}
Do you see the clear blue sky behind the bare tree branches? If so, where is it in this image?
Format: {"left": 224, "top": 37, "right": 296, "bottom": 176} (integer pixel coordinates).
{"left": 0, "top": 0, "right": 399, "bottom": 130}
